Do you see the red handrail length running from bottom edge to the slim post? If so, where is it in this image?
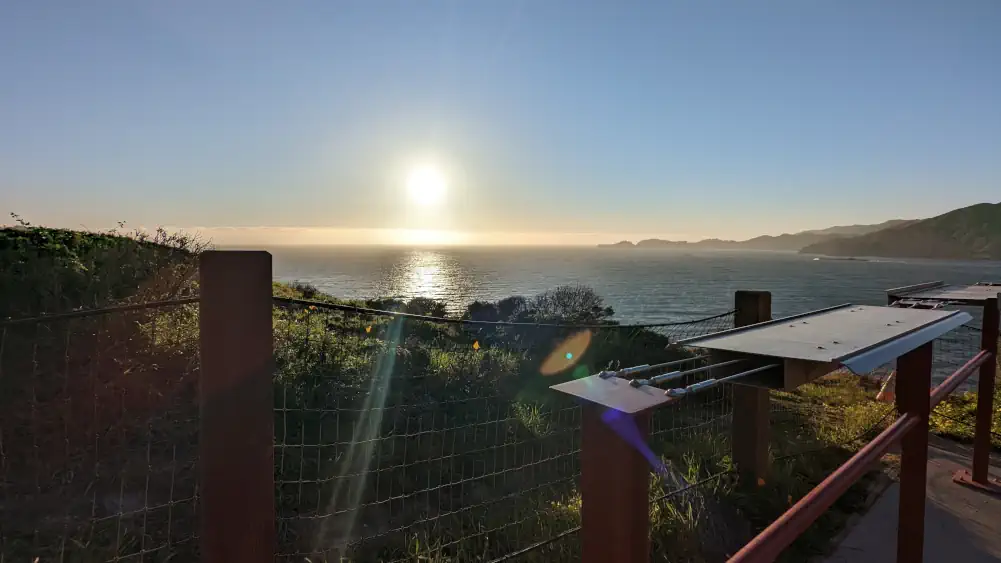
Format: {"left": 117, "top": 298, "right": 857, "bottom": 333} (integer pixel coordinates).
{"left": 730, "top": 414, "right": 920, "bottom": 563}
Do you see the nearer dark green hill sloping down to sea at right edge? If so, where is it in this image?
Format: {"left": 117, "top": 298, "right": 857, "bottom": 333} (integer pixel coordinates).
{"left": 800, "top": 203, "right": 1001, "bottom": 259}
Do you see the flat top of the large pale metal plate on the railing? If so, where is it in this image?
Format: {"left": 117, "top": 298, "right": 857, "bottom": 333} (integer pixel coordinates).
{"left": 685, "top": 306, "right": 956, "bottom": 363}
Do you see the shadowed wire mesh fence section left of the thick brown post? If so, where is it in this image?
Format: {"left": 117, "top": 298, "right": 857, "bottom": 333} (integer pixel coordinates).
{"left": 0, "top": 304, "right": 198, "bottom": 562}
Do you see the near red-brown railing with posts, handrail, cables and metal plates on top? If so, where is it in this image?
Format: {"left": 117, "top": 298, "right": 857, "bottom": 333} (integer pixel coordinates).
{"left": 551, "top": 301, "right": 976, "bottom": 563}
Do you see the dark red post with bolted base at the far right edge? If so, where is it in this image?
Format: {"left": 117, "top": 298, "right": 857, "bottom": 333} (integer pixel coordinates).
{"left": 973, "top": 298, "right": 999, "bottom": 486}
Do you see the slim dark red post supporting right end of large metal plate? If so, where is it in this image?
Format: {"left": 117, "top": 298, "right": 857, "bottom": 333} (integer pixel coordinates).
{"left": 896, "top": 343, "right": 933, "bottom": 563}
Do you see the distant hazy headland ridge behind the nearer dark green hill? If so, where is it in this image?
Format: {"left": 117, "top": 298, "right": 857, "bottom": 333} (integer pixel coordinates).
{"left": 598, "top": 219, "right": 914, "bottom": 250}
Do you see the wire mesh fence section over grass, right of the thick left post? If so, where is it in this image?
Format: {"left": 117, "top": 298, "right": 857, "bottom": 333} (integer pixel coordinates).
{"left": 274, "top": 301, "right": 733, "bottom": 561}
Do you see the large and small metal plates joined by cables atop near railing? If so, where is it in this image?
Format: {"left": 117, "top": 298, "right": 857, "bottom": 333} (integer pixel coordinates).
{"left": 552, "top": 305, "right": 972, "bottom": 414}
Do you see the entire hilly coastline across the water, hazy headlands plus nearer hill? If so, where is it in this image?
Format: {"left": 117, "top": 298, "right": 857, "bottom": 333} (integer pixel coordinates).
{"left": 599, "top": 203, "right": 1001, "bottom": 261}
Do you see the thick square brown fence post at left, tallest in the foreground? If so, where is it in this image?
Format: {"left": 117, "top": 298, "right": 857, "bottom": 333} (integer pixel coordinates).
{"left": 199, "top": 250, "right": 275, "bottom": 563}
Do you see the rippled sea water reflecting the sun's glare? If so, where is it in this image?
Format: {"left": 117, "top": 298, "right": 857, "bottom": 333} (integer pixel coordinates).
{"left": 270, "top": 246, "right": 1001, "bottom": 323}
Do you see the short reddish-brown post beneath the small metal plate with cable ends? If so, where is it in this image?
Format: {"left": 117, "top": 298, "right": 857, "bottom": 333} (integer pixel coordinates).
{"left": 581, "top": 404, "right": 651, "bottom": 563}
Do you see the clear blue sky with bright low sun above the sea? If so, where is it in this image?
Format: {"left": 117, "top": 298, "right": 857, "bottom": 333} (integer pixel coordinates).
{"left": 0, "top": 0, "right": 1001, "bottom": 244}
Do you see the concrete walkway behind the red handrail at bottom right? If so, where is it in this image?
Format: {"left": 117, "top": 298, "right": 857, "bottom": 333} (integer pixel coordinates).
{"left": 827, "top": 437, "right": 1001, "bottom": 563}
